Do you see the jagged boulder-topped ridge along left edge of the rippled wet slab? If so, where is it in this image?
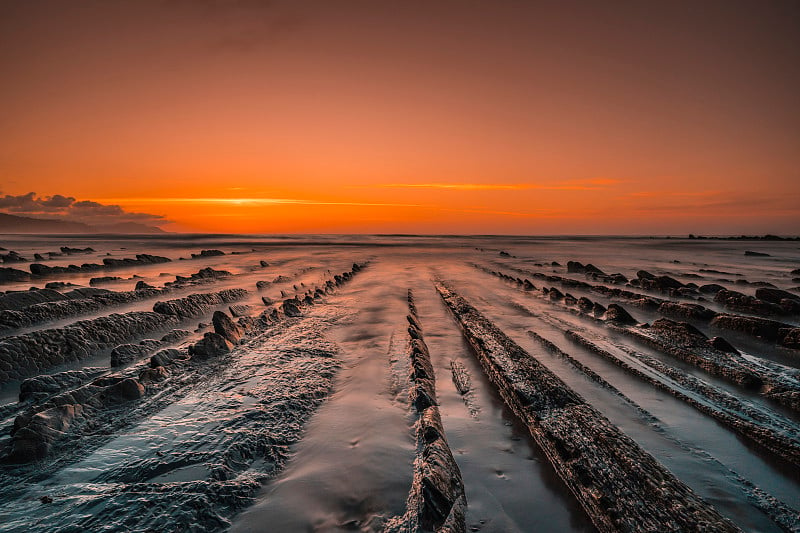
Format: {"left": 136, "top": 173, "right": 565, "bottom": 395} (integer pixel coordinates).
{"left": 0, "top": 264, "right": 362, "bottom": 463}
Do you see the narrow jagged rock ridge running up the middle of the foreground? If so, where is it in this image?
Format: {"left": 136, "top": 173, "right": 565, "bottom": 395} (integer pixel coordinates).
{"left": 384, "top": 291, "right": 467, "bottom": 533}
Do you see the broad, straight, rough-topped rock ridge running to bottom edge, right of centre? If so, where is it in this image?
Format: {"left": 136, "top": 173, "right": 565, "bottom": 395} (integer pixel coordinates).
{"left": 436, "top": 283, "right": 738, "bottom": 532}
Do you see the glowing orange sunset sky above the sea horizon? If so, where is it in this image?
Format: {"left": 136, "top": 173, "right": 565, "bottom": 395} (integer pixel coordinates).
{"left": 0, "top": 0, "right": 800, "bottom": 235}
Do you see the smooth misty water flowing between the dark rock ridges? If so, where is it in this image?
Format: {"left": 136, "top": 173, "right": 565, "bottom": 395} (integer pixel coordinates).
{"left": 0, "top": 235, "right": 800, "bottom": 532}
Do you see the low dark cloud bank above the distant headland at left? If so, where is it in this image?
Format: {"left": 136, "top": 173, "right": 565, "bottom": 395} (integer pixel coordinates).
{"left": 0, "top": 192, "right": 169, "bottom": 225}
